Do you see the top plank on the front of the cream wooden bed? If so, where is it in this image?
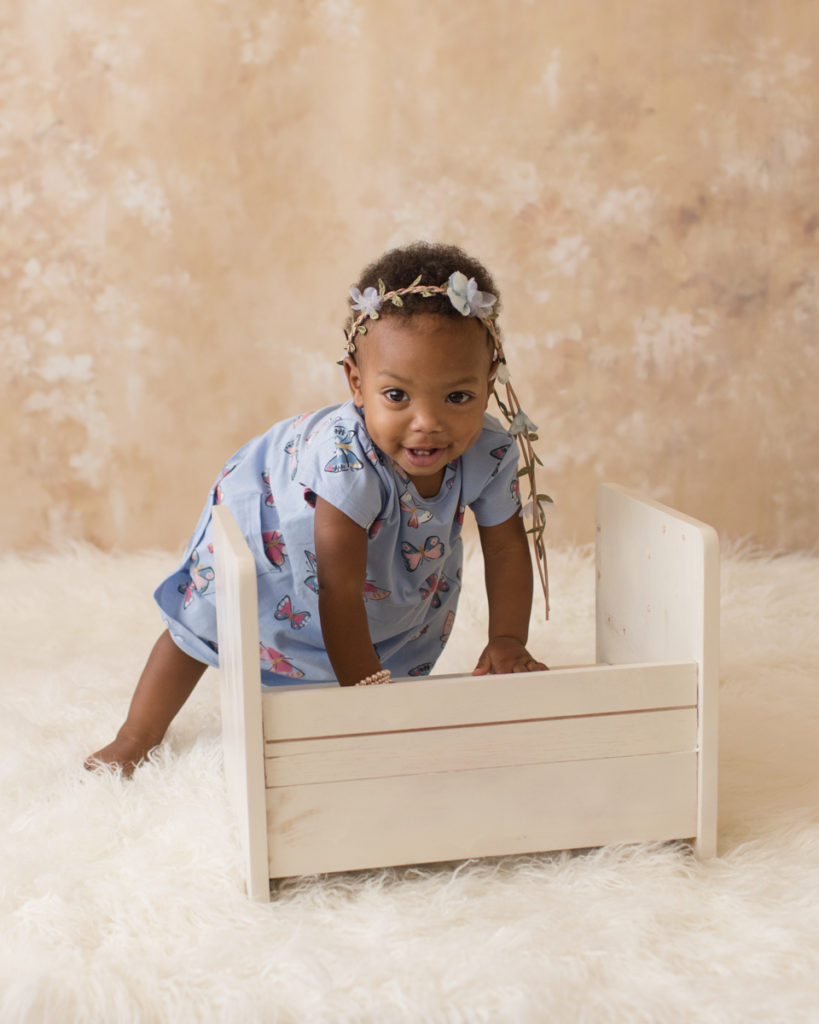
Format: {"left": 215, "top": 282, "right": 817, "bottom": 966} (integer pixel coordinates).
{"left": 262, "top": 663, "right": 697, "bottom": 740}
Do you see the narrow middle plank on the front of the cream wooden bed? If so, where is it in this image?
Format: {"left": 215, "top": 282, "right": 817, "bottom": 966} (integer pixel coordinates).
{"left": 265, "top": 708, "right": 697, "bottom": 787}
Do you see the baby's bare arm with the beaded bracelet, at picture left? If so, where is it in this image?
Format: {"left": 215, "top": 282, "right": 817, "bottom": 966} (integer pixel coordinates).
{"left": 313, "top": 498, "right": 381, "bottom": 686}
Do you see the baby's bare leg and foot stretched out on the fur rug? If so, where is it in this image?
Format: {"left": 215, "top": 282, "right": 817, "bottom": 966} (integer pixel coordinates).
{"left": 85, "top": 630, "right": 207, "bottom": 775}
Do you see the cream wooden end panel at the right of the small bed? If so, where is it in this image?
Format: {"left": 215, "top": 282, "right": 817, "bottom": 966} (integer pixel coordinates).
{"left": 596, "top": 484, "right": 720, "bottom": 856}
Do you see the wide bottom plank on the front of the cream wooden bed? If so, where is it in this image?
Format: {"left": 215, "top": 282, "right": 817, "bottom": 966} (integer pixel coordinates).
{"left": 267, "top": 753, "right": 697, "bottom": 878}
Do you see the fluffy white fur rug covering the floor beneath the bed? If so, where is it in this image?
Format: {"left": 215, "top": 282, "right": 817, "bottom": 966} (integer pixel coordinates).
{"left": 0, "top": 548, "right": 819, "bottom": 1024}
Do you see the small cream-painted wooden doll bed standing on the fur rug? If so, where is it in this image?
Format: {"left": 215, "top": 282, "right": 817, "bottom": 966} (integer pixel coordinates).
{"left": 214, "top": 484, "right": 719, "bottom": 899}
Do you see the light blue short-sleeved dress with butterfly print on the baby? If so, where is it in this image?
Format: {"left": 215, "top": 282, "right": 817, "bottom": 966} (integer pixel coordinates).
{"left": 154, "top": 400, "right": 520, "bottom": 686}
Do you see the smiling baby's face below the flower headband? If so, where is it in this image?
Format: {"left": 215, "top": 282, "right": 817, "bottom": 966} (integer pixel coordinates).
{"left": 344, "top": 313, "right": 492, "bottom": 498}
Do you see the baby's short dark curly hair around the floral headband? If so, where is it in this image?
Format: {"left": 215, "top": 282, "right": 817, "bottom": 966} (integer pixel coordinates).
{"left": 344, "top": 242, "right": 501, "bottom": 335}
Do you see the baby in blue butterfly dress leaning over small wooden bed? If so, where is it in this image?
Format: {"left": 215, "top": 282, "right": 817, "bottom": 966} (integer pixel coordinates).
{"left": 86, "top": 243, "right": 548, "bottom": 774}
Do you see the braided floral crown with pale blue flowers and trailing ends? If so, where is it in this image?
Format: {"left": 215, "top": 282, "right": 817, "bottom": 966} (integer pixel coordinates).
{"left": 345, "top": 270, "right": 552, "bottom": 618}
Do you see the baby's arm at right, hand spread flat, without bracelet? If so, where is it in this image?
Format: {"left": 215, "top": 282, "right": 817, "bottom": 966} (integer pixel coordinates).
{"left": 473, "top": 514, "right": 546, "bottom": 676}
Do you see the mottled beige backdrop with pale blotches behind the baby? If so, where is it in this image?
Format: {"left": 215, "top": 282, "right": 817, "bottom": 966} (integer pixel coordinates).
{"left": 0, "top": 0, "right": 819, "bottom": 548}
